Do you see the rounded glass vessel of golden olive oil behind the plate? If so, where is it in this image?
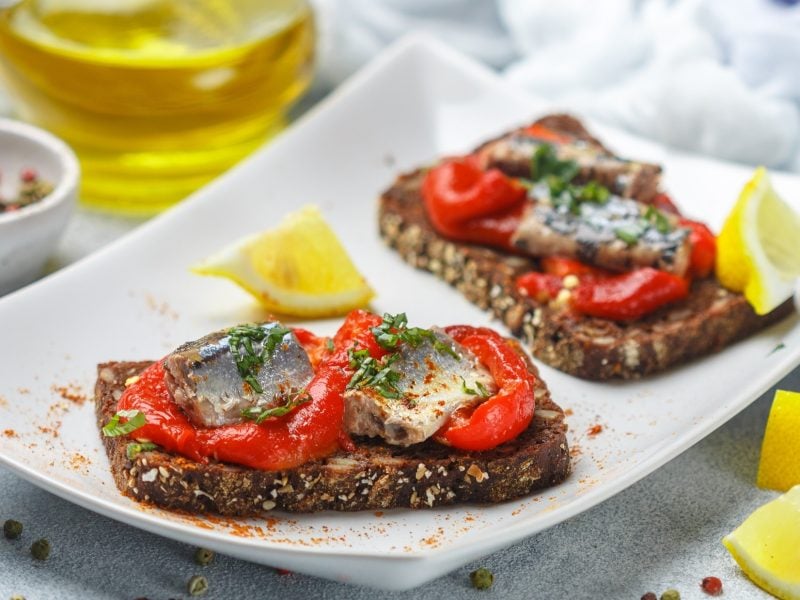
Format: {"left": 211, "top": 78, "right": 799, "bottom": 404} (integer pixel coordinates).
{"left": 0, "top": 0, "right": 314, "bottom": 214}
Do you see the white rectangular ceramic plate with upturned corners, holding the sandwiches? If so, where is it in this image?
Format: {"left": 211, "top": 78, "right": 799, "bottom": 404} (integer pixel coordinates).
{"left": 0, "top": 38, "right": 800, "bottom": 589}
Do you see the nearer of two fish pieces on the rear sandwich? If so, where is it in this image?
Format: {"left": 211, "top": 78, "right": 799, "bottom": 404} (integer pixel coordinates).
{"left": 511, "top": 184, "right": 691, "bottom": 276}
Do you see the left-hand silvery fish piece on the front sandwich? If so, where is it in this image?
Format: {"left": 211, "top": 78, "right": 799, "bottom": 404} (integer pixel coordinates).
{"left": 164, "top": 322, "right": 314, "bottom": 427}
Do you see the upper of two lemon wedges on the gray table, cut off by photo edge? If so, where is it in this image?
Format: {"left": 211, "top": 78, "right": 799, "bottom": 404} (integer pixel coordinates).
{"left": 757, "top": 390, "right": 800, "bottom": 492}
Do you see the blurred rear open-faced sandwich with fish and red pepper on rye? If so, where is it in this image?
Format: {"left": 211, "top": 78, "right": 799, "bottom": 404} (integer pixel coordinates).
{"left": 379, "top": 115, "right": 793, "bottom": 379}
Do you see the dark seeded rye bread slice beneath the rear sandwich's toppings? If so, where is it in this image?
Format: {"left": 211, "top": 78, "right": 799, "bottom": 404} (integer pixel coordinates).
{"left": 378, "top": 119, "right": 794, "bottom": 380}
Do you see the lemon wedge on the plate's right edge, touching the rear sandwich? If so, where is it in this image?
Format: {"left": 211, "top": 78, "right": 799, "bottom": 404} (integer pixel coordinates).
{"left": 716, "top": 167, "right": 800, "bottom": 315}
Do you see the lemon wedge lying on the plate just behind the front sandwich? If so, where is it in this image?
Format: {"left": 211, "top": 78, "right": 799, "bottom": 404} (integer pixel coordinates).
{"left": 192, "top": 206, "right": 375, "bottom": 317}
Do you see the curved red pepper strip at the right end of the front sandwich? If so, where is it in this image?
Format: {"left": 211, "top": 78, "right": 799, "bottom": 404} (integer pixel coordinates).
{"left": 437, "top": 325, "right": 535, "bottom": 450}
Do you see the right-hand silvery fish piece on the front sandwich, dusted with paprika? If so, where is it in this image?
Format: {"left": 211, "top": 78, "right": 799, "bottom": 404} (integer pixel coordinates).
{"left": 344, "top": 329, "right": 497, "bottom": 446}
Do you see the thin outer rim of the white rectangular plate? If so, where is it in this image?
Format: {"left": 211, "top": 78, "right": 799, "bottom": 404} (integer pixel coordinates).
{"left": 0, "top": 34, "right": 797, "bottom": 585}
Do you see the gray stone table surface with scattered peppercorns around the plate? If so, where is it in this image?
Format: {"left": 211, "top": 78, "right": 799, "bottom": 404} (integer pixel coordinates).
{"left": 0, "top": 211, "right": 800, "bottom": 600}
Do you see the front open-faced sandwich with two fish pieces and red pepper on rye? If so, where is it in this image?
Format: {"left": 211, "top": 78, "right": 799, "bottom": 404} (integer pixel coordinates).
{"left": 95, "top": 310, "right": 570, "bottom": 516}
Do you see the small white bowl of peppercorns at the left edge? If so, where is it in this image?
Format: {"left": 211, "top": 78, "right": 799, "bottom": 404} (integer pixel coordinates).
{"left": 0, "top": 119, "right": 80, "bottom": 295}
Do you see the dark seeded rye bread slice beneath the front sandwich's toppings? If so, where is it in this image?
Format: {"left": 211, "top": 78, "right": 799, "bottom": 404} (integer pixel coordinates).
{"left": 95, "top": 350, "right": 570, "bottom": 516}
